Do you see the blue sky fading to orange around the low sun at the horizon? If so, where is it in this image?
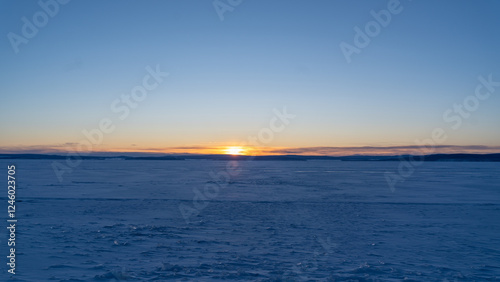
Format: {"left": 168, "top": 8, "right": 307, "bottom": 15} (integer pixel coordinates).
{"left": 0, "top": 0, "right": 500, "bottom": 155}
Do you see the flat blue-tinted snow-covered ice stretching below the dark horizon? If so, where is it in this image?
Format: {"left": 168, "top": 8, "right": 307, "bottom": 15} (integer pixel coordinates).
{"left": 0, "top": 160, "right": 500, "bottom": 281}
